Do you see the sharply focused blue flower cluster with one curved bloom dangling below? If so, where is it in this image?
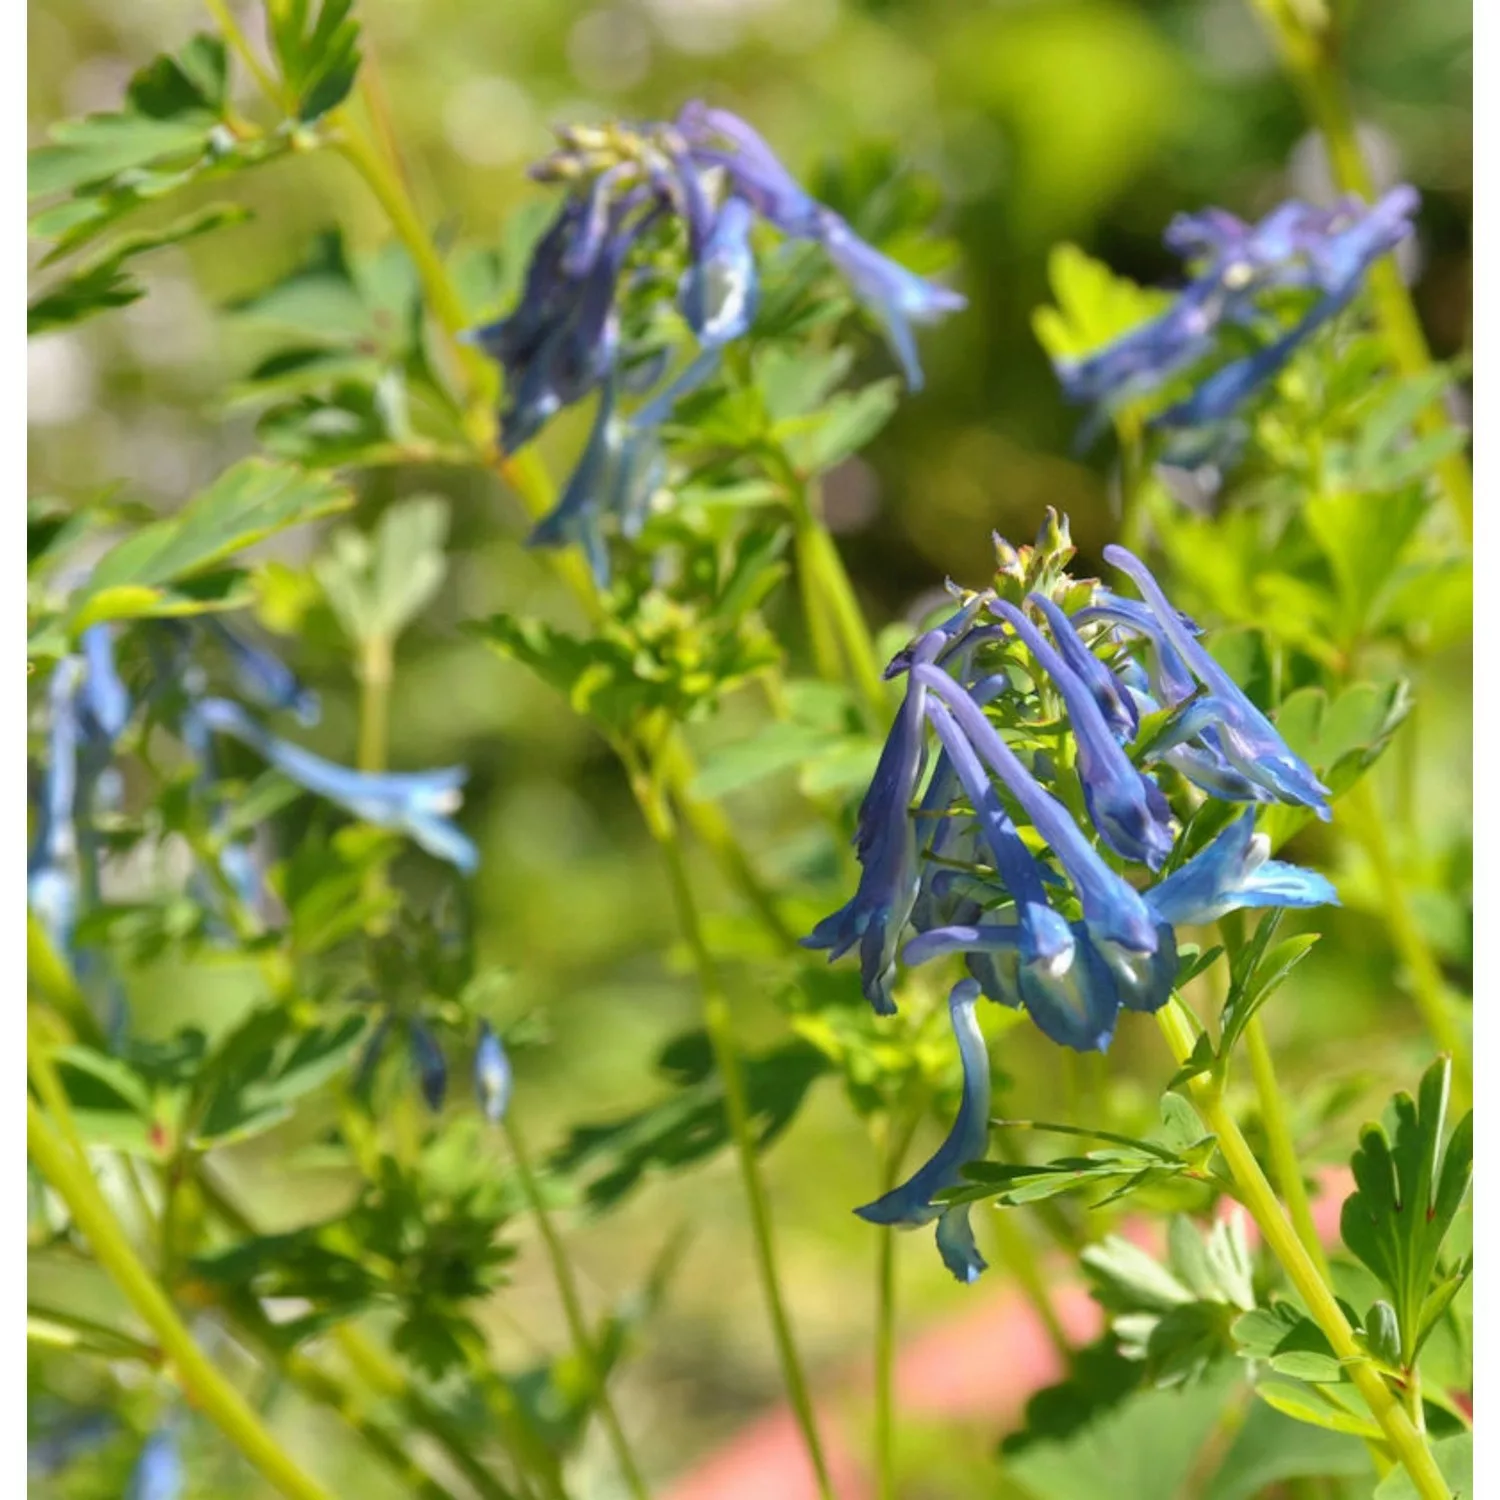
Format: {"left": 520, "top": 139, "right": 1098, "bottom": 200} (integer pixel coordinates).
{"left": 804, "top": 515, "right": 1337, "bottom": 1281}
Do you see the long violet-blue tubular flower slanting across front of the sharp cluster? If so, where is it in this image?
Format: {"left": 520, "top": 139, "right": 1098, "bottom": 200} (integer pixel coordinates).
{"left": 912, "top": 665, "right": 1157, "bottom": 954}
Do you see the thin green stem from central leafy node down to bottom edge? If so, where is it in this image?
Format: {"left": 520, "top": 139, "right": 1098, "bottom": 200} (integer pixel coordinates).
{"left": 630, "top": 771, "right": 834, "bottom": 1500}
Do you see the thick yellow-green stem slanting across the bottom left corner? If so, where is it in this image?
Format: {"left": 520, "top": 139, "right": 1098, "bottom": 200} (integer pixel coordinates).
{"left": 26, "top": 1098, "right": 333, "bottom": 1500}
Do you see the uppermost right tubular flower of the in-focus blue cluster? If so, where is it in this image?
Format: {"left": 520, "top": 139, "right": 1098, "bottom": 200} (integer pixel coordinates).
{"left": 1104, "top": 543, "right": 1332, "bottom": 821}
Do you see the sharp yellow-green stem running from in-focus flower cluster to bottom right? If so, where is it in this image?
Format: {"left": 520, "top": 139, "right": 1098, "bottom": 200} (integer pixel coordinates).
{"left": 1157, "top": 999, "right": 1452, "bottom": 1500}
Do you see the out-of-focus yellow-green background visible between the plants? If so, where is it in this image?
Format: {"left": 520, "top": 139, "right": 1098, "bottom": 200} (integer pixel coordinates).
{"left": 29, "top": 0, "right": 1473, "bottom": 1500}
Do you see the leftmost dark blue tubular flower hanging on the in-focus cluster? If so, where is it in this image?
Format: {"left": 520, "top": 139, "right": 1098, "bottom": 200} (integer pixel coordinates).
{"left": 803, "top": 674, "right": 924, "bottom": 1016}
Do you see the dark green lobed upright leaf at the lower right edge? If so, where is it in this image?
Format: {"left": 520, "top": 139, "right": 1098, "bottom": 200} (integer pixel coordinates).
{"left": 1340, "top": 1058, "right": 1475, "bottom": 1368}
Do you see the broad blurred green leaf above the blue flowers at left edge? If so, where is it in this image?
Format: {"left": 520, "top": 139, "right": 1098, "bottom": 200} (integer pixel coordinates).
{"left": 69, "top": 459, "right": 353, "bottom": 629}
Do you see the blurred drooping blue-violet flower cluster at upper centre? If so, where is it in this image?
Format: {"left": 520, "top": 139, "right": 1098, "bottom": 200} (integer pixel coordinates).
{"left": 471, "top": 102, "right": 965, "bottom": 582}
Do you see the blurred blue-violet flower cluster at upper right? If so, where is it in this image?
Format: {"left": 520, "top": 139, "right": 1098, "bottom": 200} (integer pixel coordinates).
{"left": 1056, "top": 185, "right": 1421, "bottom": 434}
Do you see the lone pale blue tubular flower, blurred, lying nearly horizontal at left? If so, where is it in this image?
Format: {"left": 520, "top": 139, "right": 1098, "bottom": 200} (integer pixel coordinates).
{"left": 198, "top": 698, "right": 479, "bottom": 875}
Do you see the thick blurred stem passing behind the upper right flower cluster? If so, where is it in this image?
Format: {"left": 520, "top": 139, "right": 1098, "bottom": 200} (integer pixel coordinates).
{"left": 1251, "top": 0, "right": 1475, "bottom": 542}
